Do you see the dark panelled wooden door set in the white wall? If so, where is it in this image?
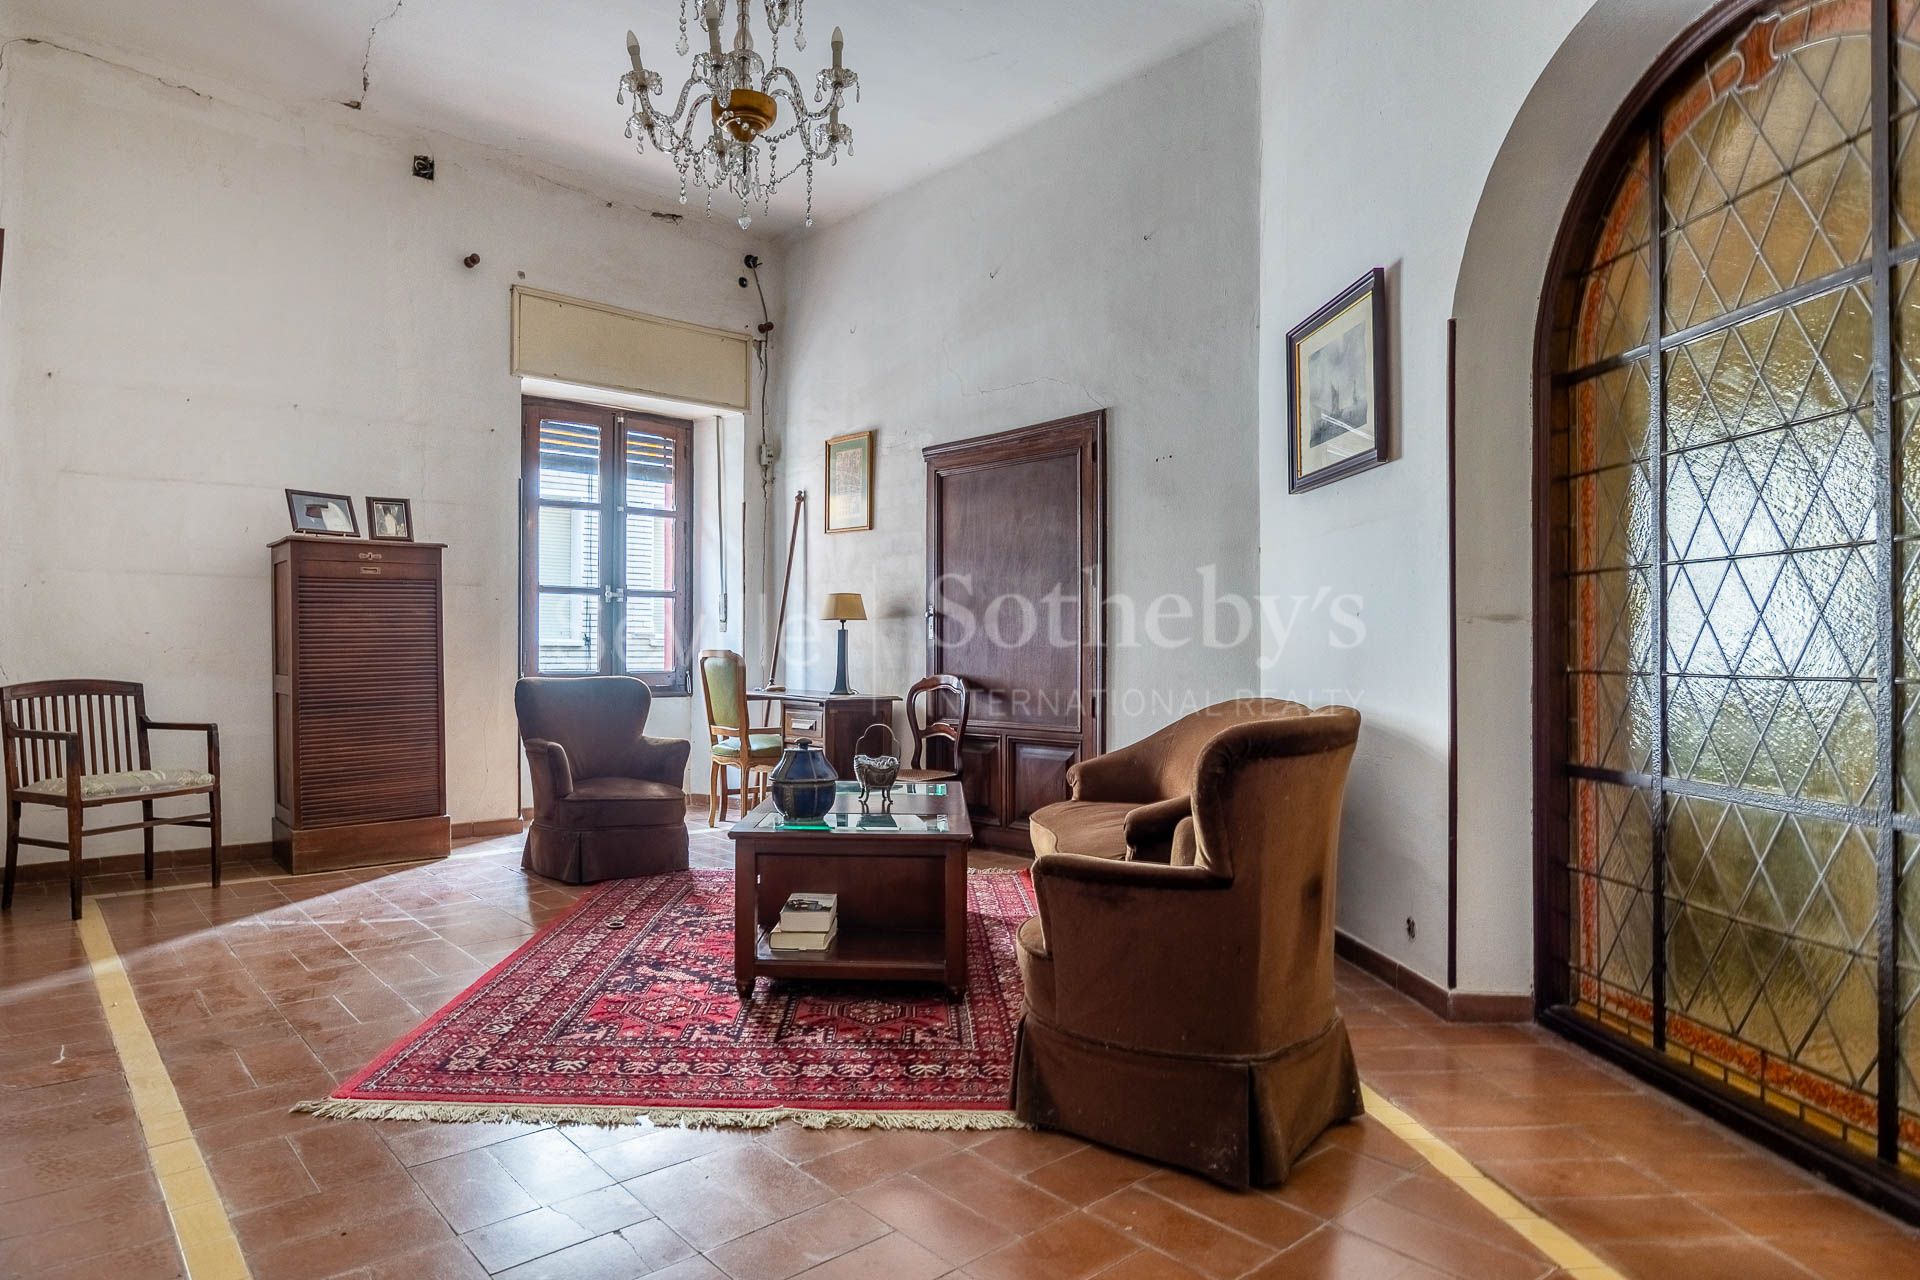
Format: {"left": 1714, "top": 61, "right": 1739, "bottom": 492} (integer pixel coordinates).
{"left": 925, "top": 413, "right": 1106, "bottom": 850}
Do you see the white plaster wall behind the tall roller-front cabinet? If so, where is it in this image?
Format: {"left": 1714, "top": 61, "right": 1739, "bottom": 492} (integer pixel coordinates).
{"left": 0, "top": 44, "right": 760, "bottom": 859}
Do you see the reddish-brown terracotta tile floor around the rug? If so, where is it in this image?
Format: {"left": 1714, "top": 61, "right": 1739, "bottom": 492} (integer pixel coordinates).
{"left": 0, "top": 821, "right": 1920, "bottom": 1280}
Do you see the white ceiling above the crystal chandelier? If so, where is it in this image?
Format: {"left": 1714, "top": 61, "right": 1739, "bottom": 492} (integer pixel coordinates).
{"left": 22, "top": 0, "right": 1260, "bottom": 230}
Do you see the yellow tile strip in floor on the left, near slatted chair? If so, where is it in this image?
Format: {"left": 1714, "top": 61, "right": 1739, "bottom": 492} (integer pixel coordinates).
{"left": 77, "top": 901, "right": 253, "bottom": 1280}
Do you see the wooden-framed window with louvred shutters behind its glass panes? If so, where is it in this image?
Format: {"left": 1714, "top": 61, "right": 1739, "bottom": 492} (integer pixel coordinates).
{"left": 520, "top": 399, "right": 693, "bottom": 693}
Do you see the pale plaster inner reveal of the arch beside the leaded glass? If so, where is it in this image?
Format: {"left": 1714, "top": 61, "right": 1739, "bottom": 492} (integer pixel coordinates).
{"left": 1453, "top": 0, "right": 1711, "bottom": 990}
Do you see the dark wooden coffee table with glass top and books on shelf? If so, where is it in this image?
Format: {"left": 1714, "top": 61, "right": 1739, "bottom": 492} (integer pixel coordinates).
{"left": 728, "top": 783, "right": 973, "bottom": 1000}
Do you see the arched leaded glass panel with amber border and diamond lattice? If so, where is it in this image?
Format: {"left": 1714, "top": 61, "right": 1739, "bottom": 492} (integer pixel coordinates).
{"left": 1534, "top": 0, "right": 1920, "bottom": 1197}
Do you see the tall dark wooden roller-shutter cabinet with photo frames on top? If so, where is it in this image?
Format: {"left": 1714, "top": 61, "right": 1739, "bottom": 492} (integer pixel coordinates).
{"left": 271, "top": 535, "right": 453, "bottom": 871}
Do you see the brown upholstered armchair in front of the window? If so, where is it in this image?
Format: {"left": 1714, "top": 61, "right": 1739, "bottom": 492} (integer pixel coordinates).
{"left": 513, "top": 676, "right": 693, "bottom": 885}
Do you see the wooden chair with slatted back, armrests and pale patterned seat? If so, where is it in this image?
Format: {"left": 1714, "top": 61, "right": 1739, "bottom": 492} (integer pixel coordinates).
{"left": 0, "top": 679, "right": 221, "bottom": 919}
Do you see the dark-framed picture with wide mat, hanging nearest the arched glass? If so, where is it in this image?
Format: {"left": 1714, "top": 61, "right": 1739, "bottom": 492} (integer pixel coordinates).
{"left": 1286, "top": 267, "right": 1388, "bottom": 493}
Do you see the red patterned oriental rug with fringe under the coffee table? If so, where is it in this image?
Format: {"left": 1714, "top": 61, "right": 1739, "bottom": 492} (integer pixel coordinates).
{"left": 296, "top": 871, "right": 1035, "bottom": 1128}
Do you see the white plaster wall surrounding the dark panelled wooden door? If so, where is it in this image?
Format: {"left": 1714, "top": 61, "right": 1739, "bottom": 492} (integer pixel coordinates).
{"left": 756, "top": 25, "right": 1260, "bottom": 745}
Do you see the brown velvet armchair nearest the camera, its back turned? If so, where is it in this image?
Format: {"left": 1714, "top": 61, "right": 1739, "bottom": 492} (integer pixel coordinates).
{"left": 1014, "top": 706, "right": 1361, "bottom": 1188}
